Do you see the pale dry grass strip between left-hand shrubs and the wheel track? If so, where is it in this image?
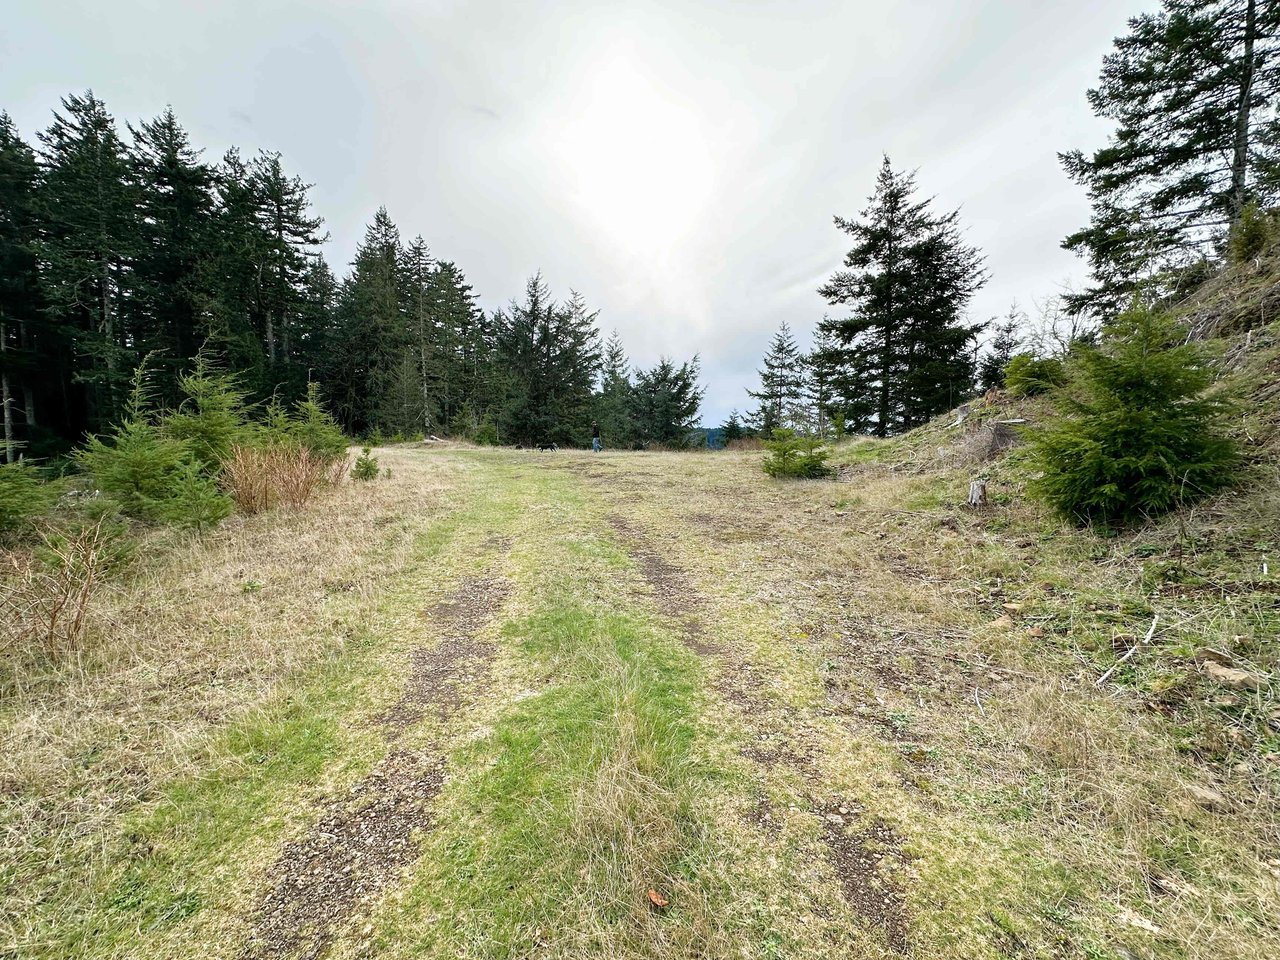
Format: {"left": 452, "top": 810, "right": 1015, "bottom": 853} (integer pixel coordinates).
{"left": 0, "top": 452, "right": 455, "bottom": 952}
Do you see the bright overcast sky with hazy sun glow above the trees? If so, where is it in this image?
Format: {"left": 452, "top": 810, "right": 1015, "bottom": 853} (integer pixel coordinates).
{"left": 0, "top": 0, "right": 1158, "bottom": 425}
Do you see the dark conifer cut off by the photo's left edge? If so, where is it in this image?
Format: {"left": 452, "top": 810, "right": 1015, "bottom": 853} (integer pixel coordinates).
{"left": 0, "top": 113, "right": 42, "bottom": 463}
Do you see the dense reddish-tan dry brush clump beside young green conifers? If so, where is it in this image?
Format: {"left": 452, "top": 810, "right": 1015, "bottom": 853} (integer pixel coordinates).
{"left": 221, "top": 443, "right": 348, "bottom": 515}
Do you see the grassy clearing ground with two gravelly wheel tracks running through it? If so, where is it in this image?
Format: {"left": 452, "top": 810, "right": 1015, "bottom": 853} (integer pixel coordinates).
{"left": 0, "top": 447, "right": 1280, "bottom": 960}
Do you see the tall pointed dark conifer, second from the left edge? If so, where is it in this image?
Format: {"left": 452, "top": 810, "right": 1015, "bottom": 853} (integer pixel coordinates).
{"left": 38, "top": 91, "right": 141, "bottom": 430}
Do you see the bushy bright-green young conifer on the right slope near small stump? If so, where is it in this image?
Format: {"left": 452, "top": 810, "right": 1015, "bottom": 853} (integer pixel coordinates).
{"left": 1032, "top": 306, "right": 1238, "bottom": 524}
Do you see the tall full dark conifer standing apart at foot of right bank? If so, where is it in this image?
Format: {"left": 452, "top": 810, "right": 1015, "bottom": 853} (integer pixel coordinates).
{"left": 819, "top": 157, "right": 986, "bottom": 436}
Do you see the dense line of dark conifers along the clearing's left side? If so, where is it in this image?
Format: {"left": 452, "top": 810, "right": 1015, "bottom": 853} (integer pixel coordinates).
{"left": 0, "top": 91, "right": 701, "bottom": 460}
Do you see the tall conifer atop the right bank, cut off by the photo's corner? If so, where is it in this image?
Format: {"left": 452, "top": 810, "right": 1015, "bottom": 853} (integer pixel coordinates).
{"left": 1061, "top": 0, "right": 1280, "bottom": 312}
